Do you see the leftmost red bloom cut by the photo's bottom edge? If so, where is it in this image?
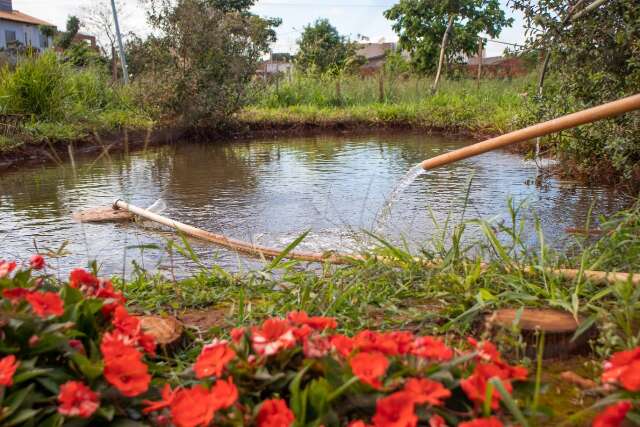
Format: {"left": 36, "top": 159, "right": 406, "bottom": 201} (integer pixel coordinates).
{"left": 171, "top": 385, "right": 216, "bottom": 427}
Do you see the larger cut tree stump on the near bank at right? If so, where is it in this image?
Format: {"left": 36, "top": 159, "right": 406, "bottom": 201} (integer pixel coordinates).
{"left": 485, "top": 309, "right": 594, "bottom": 359}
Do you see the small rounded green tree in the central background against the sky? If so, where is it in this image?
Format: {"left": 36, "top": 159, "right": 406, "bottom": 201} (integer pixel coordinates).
{"left": 295, "top": 19, "right": 363, "bottom": 74}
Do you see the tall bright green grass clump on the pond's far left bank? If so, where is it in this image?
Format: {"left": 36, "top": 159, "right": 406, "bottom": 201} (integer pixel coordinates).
{"left": 0, "top": 52, "right": 152, "bottom": 152}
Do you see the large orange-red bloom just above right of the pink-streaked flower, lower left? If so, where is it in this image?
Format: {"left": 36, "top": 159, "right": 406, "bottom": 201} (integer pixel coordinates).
{"left": 103, "top": 346, "right": 151, "bottom": 397}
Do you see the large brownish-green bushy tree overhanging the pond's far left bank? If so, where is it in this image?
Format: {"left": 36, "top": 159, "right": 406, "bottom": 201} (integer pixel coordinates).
{"left": 135, "top": 0, "right": 280, "bottom": 127}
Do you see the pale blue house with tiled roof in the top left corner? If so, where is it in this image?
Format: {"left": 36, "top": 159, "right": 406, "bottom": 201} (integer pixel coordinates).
{"left": 0, "top": 0, "right": 54, "bottom": 50}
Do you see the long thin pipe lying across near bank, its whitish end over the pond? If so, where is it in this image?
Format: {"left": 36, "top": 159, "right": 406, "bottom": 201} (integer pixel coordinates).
{"left": 113, "top": 199, "right": 640, "bottom": 285}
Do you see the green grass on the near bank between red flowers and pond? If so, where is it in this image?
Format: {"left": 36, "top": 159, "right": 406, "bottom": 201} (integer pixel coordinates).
{"left": 119, "top": 201, "right": 640, "bottom": 357}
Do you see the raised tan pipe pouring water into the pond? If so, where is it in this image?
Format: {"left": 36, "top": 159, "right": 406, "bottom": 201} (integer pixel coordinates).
{"left": 420, "top": 94, "right": 640, "bottom": 170}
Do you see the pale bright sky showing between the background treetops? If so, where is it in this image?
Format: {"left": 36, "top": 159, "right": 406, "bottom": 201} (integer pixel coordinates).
{"left": 13, "top": 0, "right": 524, "bottom": 56}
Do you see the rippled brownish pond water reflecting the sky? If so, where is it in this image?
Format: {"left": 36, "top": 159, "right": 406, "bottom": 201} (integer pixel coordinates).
{"left": 0, "top": 134, "right": 629, "bottom": 276}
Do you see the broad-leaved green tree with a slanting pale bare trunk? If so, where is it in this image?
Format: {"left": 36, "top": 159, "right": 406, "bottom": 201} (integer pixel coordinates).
{"left": 384, "top": 0, "right": 513, "bottom": 88}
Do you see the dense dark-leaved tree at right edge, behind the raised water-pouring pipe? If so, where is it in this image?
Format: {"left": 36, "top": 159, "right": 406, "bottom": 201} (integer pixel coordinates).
{"left": 513, "top": 0, "right": 640, "bottom": 181}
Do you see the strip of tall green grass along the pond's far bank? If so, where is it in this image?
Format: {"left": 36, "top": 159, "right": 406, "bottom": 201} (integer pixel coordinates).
{"left": 237, "top": 76, "right": 533, "bottom": 133}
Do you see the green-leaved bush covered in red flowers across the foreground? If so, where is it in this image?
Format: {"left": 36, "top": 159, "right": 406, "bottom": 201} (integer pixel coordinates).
{"left": 0, "top": 255, "right": 540, "bottom": 427}
